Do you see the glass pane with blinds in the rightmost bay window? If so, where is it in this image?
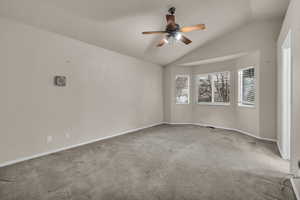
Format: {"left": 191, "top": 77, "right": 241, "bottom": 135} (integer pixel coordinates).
{"left": 241, "top": 68, "right": 255, "bottom": 105}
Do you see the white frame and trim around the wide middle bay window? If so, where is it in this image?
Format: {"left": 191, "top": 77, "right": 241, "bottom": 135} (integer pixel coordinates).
{"left": 195, "top": 71, "right": 231, "bottom": 106}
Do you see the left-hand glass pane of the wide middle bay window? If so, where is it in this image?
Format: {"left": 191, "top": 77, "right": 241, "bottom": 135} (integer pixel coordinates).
{"left": 197, "top": 75, "right": 212, "bottom": 103}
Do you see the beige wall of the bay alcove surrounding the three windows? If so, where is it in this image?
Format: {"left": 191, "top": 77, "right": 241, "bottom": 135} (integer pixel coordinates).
{"left": 165, "top": 52, "right": 260, "bottom": 137}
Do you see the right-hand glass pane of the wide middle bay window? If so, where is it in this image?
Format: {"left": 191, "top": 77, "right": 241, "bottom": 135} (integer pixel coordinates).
{"left": 214, "top": 72, "right": 230, "bottom": 103}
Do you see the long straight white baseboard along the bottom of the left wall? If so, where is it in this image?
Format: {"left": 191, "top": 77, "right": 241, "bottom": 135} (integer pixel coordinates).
{"left": 0, "top": 122, "right": 165, "bottom": 168}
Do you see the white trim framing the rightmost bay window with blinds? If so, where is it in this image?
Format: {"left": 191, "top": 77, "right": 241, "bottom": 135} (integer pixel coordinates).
{"left": 238, "top": 66, "right": 257, "bottom": 108}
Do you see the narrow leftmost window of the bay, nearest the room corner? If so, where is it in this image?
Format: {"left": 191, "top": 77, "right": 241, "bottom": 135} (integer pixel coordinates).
{"left": 175, "top": 75, "right": 190, "bottom": 104}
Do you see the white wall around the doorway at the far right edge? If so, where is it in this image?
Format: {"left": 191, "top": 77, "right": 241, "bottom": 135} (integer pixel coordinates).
{"left": 277, "top": 0, "right": 300, "bottom": 173}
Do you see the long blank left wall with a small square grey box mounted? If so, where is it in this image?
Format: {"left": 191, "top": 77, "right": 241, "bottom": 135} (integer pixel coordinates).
{"left": 0, "top": 19, "right": 163, "bottom": 164}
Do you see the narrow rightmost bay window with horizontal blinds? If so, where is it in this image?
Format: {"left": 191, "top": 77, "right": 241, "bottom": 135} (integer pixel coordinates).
{"left": 239, "top": 67, "right": 256, "bottom": 106}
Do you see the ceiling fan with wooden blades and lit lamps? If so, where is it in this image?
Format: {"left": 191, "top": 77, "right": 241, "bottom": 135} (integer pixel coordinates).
{"left": 142, "top": 7, "right": 206, "bottom": 47}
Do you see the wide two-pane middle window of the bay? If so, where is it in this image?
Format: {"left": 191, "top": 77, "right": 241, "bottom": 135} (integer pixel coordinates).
{"left": 196, "top": 72, "right": 230, "bottom": 105}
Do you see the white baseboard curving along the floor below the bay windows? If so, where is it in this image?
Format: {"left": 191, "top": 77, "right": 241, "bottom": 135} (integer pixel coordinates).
{"left": 165, "top": 122, "right": 277, "bottom": 143}
